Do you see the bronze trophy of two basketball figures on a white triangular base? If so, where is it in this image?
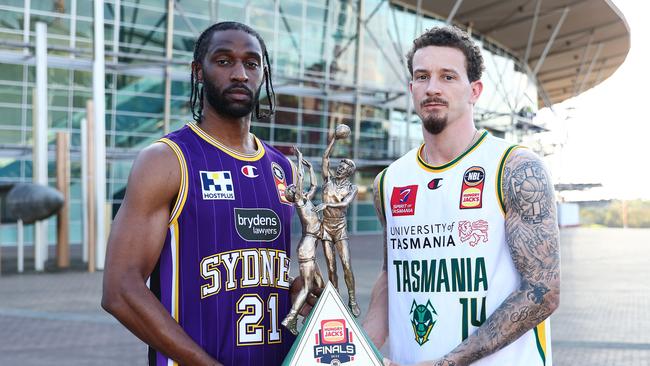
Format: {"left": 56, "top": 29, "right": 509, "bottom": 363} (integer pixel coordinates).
{"left": 282, "top": 125, "right": 382, "bottom": 366}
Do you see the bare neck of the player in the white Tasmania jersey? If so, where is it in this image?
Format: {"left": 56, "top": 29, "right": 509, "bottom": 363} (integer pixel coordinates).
{"left": 422, "top": 119, "right": 477, "bottom": 166}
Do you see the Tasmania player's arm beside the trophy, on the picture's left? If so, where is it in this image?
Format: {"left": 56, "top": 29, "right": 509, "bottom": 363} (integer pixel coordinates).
{"left": 363, "top": 173, "right": 388, "bottom": 348}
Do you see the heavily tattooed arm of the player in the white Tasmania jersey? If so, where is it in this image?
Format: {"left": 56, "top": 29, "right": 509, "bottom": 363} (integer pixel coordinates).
{"left": 418, "top": 149, "right": 560, "bottom": 366}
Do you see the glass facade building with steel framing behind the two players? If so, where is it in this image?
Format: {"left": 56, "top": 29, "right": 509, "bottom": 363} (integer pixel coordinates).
{"left": 0, "top": 0, "right": 538, "bottom": 249}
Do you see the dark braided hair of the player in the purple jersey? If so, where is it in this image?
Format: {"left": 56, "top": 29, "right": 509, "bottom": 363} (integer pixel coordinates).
{"left": 190, "top": 22, "right": 275, "bottom": 123}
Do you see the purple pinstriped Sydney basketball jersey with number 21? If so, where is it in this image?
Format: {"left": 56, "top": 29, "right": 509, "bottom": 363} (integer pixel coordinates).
{"left": 149, "top": 123, "right": 294, "bottom": 366}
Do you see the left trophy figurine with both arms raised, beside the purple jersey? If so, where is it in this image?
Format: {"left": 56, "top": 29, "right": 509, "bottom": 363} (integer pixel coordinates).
{"left": 282, "top": 146, "right": 325, "bottom": 334}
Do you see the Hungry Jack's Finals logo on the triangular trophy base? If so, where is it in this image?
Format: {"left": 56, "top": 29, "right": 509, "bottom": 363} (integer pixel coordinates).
{"left": 314, "top": 319, "right": 357, "bottom": 366}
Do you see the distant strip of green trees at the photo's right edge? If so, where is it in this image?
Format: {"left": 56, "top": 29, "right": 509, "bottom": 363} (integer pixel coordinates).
{"left": 580, "top": 200, "right": 650, "bottom": 228}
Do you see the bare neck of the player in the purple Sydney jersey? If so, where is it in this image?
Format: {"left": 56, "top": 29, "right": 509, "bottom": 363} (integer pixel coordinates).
{"left": 199, "top": 107, "right": 257, "bottom": 154}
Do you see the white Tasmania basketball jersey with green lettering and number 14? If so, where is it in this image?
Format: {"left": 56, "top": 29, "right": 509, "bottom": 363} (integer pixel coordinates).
{"left": 380, "top": 131, "right": 551, "bottom": 366}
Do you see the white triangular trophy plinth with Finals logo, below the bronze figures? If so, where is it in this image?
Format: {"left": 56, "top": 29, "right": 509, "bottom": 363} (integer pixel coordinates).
{"left": 282, "top": 282, "right": 383, "bottom": 366}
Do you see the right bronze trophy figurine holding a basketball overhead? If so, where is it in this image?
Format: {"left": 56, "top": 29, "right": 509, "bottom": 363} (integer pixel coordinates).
{"left": 314, "top": 124, "right": 361, "bottom": 318}
